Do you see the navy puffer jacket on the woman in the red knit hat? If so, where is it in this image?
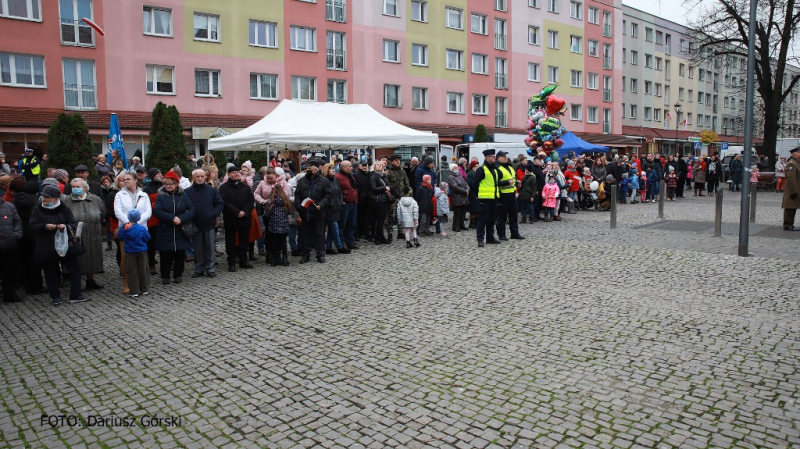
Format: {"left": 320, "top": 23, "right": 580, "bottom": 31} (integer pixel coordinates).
{"left": 153, "top": 187, "right": 194, "bottom": 251}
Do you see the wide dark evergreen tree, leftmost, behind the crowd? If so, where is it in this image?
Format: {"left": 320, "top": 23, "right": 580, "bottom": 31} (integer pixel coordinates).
{"left": 47, "top": 112, "right": 97, "bottom": 180}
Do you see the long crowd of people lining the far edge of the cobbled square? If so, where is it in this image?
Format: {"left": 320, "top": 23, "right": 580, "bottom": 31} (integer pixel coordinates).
{"left": 0, "top": 148, "right": 800, "bottom": 305}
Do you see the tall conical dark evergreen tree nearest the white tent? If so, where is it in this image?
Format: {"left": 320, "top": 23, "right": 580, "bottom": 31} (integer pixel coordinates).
{"left": 145, "top": 101, "right": 190, "bottom": 177}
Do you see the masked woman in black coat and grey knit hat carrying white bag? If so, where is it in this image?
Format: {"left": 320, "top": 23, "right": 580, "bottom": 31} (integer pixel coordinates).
{"left": 29, "top": 185, "right": 89, "bottom": 306}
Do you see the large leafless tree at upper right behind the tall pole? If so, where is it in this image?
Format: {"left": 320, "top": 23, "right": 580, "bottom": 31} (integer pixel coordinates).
{"left": 684, "top": 0, "right": 800, "bottom": 158}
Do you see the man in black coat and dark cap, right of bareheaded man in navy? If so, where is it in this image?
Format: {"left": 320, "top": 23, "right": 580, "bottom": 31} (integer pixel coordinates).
{"left": 219, "top": 165, "right": 255, "bottom": 272}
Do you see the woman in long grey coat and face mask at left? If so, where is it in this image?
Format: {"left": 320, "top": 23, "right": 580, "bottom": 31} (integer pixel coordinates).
{"left": 65, "top": 178, "right": 106, "bottom": 290}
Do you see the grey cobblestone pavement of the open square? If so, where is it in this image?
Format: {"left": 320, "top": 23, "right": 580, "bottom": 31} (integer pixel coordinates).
{"left": 0, "top": 192, "right": 800, "bottom": 449}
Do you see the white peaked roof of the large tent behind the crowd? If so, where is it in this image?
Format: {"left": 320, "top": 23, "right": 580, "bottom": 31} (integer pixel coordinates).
{"left": 208, "top": 100, "right": 439, "bottom": 151}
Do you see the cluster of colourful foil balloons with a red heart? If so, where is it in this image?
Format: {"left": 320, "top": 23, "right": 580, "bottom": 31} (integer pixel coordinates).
{"left": 525, "top": 83, "right": 567, "bottom": 156}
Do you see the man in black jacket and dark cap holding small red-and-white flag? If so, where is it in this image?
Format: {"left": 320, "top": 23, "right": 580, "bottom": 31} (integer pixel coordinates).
{"left": 294, "top": 159, "right": 333, "bottom": 263}
